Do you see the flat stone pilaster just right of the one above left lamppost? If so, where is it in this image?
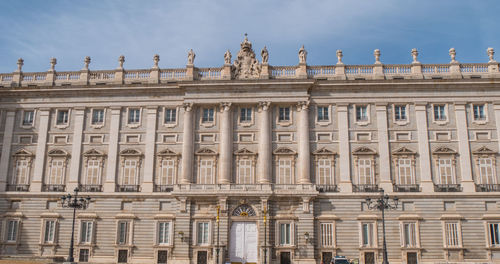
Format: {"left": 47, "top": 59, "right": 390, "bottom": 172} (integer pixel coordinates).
{"left": 104, "top": 107, "right": 121, "bottom": 192}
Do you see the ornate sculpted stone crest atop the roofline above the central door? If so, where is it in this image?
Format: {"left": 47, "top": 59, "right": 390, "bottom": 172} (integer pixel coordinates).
{"left": 232, "top": 34, "right": 261, "bottom": 79}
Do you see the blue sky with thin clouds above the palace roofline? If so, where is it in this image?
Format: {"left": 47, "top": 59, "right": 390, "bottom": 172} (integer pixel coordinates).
{"left": 0, "top": 0, "right": 500, "bottom": 72}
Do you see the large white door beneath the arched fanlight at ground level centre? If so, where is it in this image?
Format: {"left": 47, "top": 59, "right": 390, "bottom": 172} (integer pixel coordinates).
{"left": 229, "top": 222, "right": 257, "bottom": 263}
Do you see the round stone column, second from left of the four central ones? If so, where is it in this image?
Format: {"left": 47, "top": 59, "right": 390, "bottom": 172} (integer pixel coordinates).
{"left": 218, "top": 103, "right": 233, "bottom": 184}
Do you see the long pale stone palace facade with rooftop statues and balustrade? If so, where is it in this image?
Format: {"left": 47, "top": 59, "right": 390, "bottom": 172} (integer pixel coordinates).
{"left": 0, "top": 38, "right": 500, "bottom": 264}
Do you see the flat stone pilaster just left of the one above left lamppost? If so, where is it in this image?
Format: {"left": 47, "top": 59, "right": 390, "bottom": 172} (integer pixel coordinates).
{"left": 30, "top": 109, "right": 50, "bottom": 192}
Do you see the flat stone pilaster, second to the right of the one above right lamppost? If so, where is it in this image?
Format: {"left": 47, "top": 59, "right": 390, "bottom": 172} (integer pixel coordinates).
{"left": 455, "top": 102, "right": 475, "bottom": 192}
